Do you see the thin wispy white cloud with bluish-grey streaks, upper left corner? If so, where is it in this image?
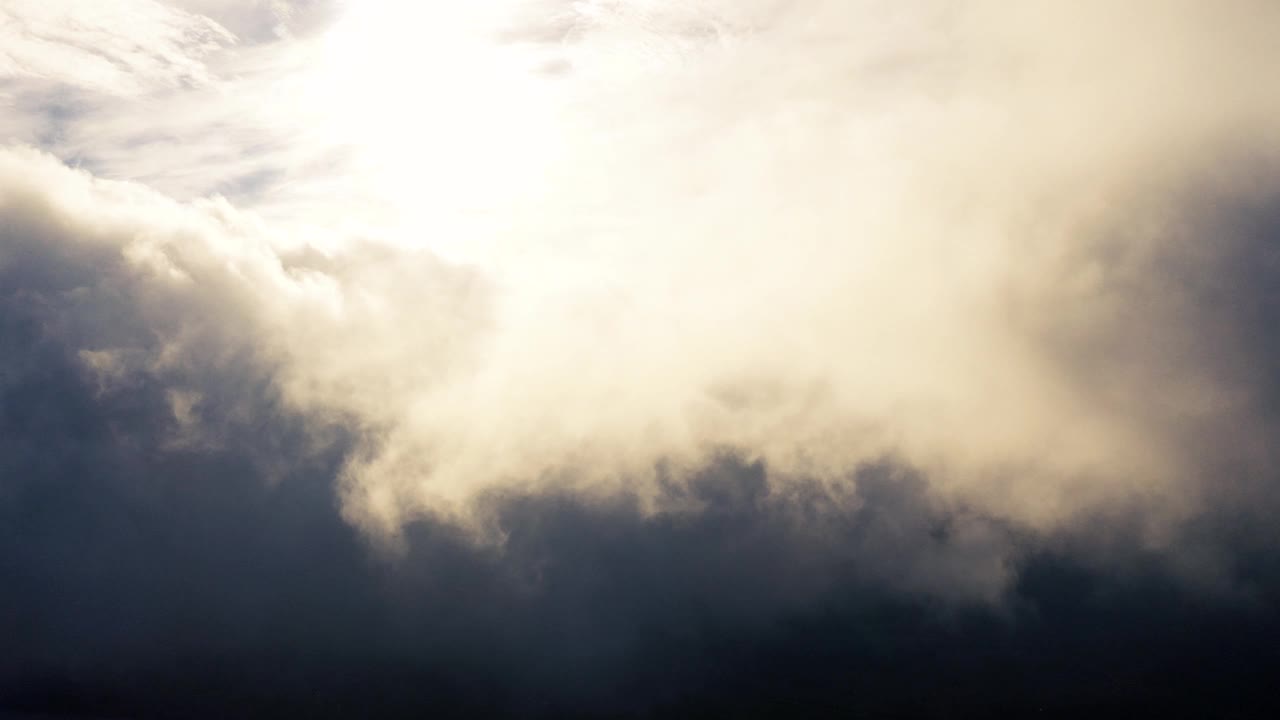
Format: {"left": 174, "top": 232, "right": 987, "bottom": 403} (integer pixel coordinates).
{"left": 0, "top": 0, "right": 361, "bottom": 229}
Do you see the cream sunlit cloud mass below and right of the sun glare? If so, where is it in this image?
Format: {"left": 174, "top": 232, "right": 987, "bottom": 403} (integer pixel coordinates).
{"left": 9, "top": 3, "right": 1276, "bottom": 548}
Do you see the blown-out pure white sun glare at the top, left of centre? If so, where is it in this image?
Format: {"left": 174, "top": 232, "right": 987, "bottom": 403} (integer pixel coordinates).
{"left": 308, "top": 0, "right": 557, "bottom": 261}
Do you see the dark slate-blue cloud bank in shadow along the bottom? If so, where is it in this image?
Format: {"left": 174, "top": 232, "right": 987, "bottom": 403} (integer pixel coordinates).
{"left": 0, "top": 260, "right": 1280, "bottom": 717}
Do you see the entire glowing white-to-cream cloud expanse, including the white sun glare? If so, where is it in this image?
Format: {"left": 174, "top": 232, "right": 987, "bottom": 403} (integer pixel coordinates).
{"left": 4, "top": 0, "right": 1280, "bottom": 558}
